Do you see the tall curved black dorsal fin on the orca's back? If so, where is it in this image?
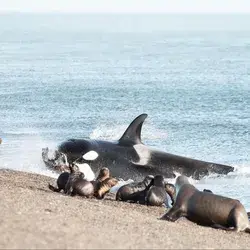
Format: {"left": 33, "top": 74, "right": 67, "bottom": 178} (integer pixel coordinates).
{"left": 119, "top": 114, "right": 148, "bottom": 144}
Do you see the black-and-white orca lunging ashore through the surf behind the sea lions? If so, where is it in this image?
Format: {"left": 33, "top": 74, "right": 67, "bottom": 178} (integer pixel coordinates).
{"left": 41, "top": 114, "right": 234, "bottom": 180}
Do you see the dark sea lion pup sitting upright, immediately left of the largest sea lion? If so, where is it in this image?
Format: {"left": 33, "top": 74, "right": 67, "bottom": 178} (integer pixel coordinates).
{"left": 145, "top": 175, "right": 173, "bottom": 206}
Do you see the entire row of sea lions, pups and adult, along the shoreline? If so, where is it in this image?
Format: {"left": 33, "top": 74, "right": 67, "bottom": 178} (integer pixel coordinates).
{"left": 48, "top": 161, "right": 250, "bottom": 233}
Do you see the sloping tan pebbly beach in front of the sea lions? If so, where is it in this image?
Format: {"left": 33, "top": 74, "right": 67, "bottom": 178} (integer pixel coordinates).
{"left": 0, "top": 170, "right": 250, "bottom": 249}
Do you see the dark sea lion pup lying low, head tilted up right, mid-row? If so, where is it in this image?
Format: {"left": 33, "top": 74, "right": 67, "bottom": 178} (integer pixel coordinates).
{"left": 116, "top": 175, "right": 154, "bottom": 202}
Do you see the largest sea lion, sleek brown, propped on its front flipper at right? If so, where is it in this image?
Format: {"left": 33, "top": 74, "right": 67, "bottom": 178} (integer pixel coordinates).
{"left": 161, "top": 176, "right": 250, "bottom": 233}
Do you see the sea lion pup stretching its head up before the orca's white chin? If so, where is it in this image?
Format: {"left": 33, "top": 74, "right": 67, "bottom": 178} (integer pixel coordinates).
{"left": 65, "top": 164, "right": 94, "bottom": 198}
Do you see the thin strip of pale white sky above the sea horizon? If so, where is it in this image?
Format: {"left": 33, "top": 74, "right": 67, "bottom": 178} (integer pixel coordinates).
{"left": 0, "top": 0, "right": 250, "bottom": 13}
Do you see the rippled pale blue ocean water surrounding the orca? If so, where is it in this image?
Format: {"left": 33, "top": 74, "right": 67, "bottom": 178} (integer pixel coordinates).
{"left": 0, "top": 13, "right": 250, "bottom": 210}
